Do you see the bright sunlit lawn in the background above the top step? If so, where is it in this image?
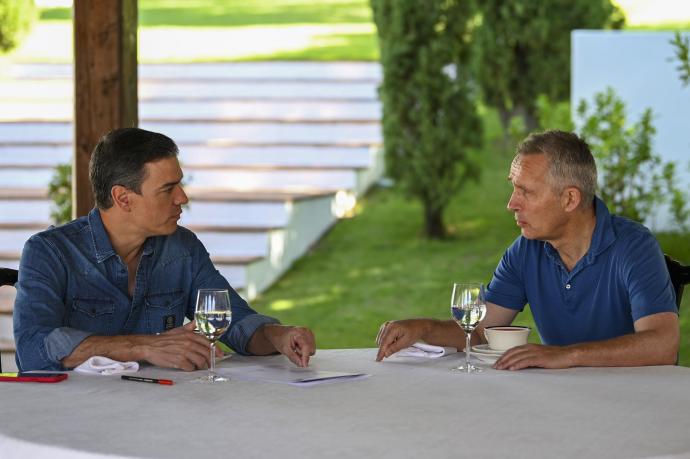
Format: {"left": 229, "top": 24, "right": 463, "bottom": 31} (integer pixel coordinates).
{"left": 8, "top": 0, "right": 690, "bottom": 63}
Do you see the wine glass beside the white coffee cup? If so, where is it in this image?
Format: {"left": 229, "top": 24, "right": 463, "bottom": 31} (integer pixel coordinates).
{"left": 450, "top": 282, "right": 486, "bottom": 373}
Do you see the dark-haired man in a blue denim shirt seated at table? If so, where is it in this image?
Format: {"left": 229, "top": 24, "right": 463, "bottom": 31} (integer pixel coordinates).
{"left": 14, "top": 128, "right": 315, "bottom": 371}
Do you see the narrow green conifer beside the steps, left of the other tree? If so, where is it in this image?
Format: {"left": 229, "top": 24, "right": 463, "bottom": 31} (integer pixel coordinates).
{"left": 371, "top": 0, "right": 482, "bottom": 238}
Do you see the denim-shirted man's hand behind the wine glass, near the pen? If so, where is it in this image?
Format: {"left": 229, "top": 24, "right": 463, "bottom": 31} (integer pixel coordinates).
{"left": 139, "top": 321, "right": 222, "bottom": 371}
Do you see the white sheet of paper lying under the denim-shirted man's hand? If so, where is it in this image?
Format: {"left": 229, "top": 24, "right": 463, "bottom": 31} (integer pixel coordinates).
{"left": 216, "top": 365, "right": 371, "bottom": 387}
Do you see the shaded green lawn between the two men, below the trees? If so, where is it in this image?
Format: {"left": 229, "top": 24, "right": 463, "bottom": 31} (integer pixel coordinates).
{"left": 253, "top": 108, "right": 690, "bottom": 365}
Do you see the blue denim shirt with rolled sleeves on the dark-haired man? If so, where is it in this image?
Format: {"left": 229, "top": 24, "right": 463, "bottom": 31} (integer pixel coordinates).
{"left": 14, "top": 209, "right": 278, "bottom": 371}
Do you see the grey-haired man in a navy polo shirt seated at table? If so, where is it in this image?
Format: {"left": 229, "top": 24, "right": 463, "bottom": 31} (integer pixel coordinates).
{"left": 377, "top": 131, "right": 680, "bottom": 370}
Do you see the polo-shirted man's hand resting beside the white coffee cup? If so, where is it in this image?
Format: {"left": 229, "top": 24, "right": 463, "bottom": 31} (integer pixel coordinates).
{"left": 493, "top": 344, "right": 573, "bottom": 370}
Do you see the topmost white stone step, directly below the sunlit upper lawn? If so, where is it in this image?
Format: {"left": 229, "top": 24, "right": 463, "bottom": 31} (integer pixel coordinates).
{"left": 0, "top": 62, "right": 382, "bottom": 82}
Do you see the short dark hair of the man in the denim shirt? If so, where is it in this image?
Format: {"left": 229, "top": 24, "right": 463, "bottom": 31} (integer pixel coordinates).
{"left": 89, "top": 128, "right": 178, "bottom": 209}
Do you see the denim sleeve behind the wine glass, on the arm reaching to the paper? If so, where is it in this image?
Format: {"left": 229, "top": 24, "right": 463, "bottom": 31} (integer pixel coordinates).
{"left": 187, "top": 236, "right": 280, "bottom": 355}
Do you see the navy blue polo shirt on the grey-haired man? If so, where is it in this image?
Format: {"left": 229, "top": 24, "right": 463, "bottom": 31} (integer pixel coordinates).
{"left": 486, "top": 198, "right": 678, "bottom": 346}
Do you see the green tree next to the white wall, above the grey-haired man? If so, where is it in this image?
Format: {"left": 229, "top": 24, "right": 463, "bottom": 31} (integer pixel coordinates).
{"left": 476, "top": 0, "right": 625, "bottom": 132}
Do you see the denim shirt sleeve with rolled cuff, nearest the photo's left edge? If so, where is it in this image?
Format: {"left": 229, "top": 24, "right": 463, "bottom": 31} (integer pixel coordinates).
{"left": 13, "top": 235, "right": 91, "bottom": 371}
